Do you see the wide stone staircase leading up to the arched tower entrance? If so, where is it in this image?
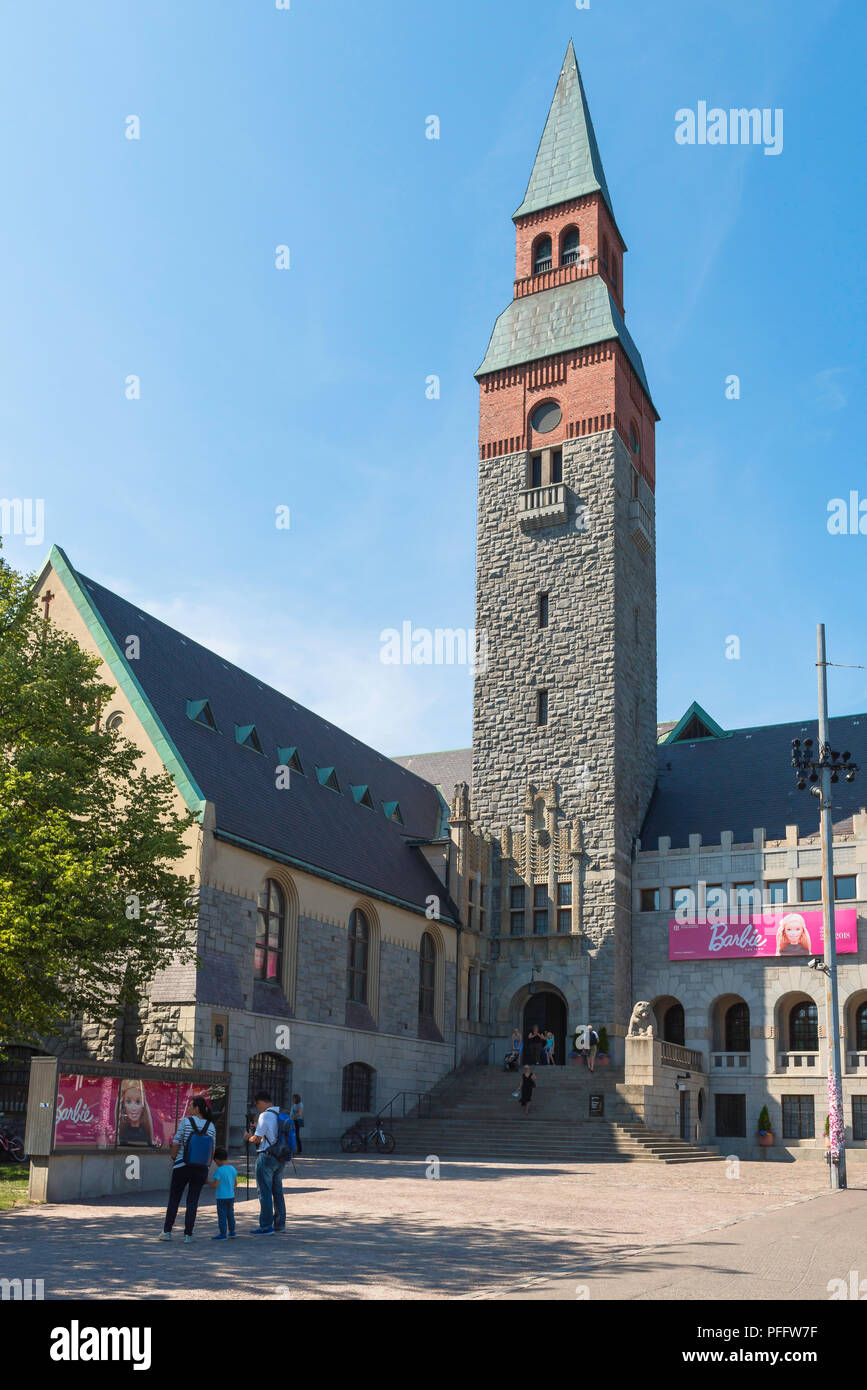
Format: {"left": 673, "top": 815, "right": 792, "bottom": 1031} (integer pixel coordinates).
{"left": 385, "top": 1066, "right": 723, "bottom": 1163}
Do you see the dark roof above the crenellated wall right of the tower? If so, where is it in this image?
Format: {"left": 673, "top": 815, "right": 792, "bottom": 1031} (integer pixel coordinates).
{"left": 641, "top": 714, "right": 867, "bottom": 849}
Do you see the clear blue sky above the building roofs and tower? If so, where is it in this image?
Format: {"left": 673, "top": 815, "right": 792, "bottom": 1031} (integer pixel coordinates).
{"left": 0, "top": 0, "right": 867, "bottom": 753}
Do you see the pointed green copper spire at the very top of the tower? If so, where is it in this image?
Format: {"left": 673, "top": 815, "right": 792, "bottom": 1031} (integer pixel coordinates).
{"left": 514, "top": 39, "right": 614, "bottom": 220}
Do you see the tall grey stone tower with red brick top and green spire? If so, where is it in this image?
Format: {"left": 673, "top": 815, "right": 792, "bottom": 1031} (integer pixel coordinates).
{"left": 472, "top": 43, "right": 659, "bottom": 1034}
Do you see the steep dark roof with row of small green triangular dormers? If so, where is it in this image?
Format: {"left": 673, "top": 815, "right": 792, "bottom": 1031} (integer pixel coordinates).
{"left": 51, "top": 549, "right": 457, "bottom": 919}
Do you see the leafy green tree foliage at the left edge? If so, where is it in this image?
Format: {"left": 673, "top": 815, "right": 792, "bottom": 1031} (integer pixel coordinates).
{"left": 0, "top": 553, "right": 196, "bottom": 1043}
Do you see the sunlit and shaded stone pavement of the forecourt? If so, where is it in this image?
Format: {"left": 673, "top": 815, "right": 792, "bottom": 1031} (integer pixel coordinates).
{"left": 0, "top": 1156, "right": 867, "bottom": 1300}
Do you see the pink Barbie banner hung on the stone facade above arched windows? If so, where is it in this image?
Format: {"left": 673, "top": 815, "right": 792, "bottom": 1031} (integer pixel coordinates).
{"left": 668, "top": 908, "right": 857, "bottom": 960}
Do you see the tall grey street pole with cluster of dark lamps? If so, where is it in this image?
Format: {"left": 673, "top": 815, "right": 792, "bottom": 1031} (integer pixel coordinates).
{"left": 792, "top": 623, "right": 857, "bottom": 1190}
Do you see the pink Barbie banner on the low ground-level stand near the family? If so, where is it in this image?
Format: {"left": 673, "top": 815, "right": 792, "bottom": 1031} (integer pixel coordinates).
{"left": 54, "top": 1074, "right": 210, "bottom": 1148}
